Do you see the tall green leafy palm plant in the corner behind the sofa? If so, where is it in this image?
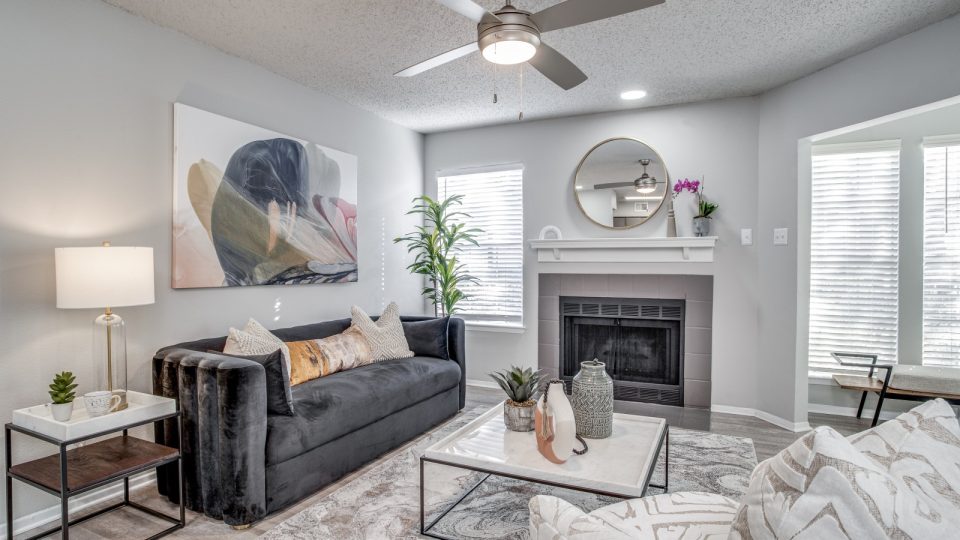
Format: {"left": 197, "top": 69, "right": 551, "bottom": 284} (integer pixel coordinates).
{"left": 393, "top": 195, "right": 480, "bottom": 317}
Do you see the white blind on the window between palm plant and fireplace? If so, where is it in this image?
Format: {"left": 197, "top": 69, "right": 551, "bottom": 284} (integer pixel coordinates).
{"left": 437, "top": 165, "right": 523, "bottom": 325}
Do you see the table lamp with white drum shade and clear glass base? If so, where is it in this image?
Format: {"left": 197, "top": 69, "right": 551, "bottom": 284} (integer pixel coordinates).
{"left": 55, "top": 242, "right": 154, "bottom": 410}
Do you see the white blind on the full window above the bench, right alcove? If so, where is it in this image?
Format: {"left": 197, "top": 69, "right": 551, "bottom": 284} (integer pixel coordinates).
{"left": 809, "top": 141, "right": 900, "bottom": 371}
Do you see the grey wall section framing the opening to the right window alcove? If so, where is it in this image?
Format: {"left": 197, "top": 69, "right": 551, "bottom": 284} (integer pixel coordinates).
{"left": 755, "top": 12, "right": 960, "bottom": 422}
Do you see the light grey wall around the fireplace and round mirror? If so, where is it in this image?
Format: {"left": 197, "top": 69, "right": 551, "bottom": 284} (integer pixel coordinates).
{"left": 424, "top": 98, "right": 758, "bottom": 414}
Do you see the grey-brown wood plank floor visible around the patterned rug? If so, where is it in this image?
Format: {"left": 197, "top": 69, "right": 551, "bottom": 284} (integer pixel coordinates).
{"left": 17, "top": 386, "right": 870, "bottom": 539}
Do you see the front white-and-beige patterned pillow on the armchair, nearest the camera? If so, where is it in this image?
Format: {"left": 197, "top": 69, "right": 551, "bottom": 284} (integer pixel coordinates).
{"left": 730, "top": 427, "right": 960, "bottom": 539}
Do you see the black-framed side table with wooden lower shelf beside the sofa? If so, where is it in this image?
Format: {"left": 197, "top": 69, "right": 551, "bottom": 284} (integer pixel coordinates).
{"left": 4, "top": 392, "right": 186, "bottom": 540}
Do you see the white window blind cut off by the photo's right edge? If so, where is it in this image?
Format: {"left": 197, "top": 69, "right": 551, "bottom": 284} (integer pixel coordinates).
{"left": 923, "top": 137, "right": 960, "bottom": 366}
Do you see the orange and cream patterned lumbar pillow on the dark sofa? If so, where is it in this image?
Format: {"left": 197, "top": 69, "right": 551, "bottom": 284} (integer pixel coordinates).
{"left": 287, "top": 328, "right": 373, "bottom": 386}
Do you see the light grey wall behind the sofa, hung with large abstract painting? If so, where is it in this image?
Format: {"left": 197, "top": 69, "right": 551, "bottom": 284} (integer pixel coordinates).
{"left": 0, "top": 0, "right": 423, "bottom": 528}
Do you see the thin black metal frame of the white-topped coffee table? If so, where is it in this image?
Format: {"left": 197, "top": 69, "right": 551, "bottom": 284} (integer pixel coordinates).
{"left": 420, "top": 424, "right": 670, "bottom": 540}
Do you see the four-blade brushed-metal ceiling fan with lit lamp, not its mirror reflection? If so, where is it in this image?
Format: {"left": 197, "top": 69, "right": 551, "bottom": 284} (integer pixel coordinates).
{"left": 395, "top": 0, "right": 665, "bottom": 90}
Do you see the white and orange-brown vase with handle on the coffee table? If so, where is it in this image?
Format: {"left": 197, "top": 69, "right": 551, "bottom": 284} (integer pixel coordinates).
{"left": 534, "top": 380, "right": 577, "bottom": 464}
